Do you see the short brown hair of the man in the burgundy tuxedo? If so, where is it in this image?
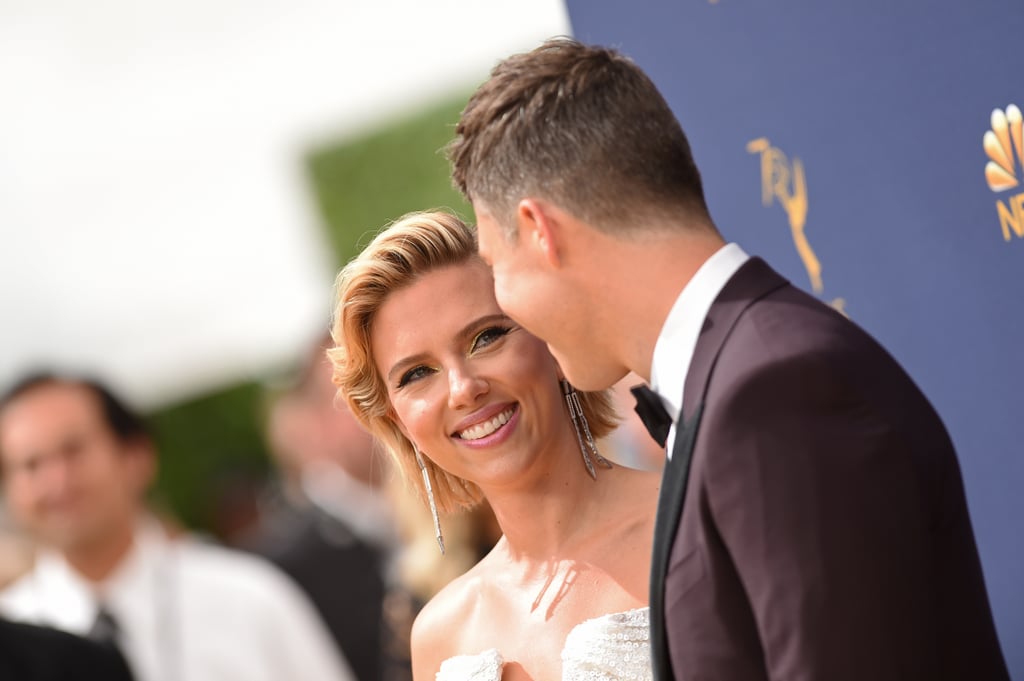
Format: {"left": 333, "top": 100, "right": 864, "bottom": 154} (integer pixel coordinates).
{"left": 447, "top": 38, "right": 708, "bottom": 229}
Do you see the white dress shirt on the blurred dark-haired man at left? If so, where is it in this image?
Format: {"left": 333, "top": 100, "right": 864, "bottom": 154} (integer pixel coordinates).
{"left": 0, "top": 518, "right": 354, "bottom": 681}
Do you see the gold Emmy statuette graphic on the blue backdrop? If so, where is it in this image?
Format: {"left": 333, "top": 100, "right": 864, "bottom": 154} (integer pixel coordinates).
{"left": 746, "top": 137, "right": 846, "bottom": 314}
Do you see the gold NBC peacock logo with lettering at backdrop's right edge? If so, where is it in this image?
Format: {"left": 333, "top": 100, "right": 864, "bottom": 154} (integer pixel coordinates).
{"left": 982, "top": 104, "right": 1024, "bottom": 242}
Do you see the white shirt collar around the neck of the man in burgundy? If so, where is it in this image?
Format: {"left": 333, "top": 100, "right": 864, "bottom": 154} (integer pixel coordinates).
{"left": 650, "top": 244, "right": 750, "bottom": 459}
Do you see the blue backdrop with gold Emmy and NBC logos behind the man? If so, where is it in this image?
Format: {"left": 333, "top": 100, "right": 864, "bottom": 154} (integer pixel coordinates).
{"left": 567, "top": 0, "right": 1024, "bottom": 667}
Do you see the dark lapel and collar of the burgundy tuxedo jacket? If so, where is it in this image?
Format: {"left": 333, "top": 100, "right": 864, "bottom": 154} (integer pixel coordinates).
{"left": 650, "top": 258, "right": 787, "bottom": 681}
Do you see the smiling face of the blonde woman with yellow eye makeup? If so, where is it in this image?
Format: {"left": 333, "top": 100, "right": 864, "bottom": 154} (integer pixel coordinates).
{"left": 371, "top": 258, "right": 568, "bottom": 490}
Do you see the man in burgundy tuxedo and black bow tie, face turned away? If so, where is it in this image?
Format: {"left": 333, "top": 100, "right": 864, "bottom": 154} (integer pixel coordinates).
{"left": 449, "top": 39, "right": 1008, "bottom": 681}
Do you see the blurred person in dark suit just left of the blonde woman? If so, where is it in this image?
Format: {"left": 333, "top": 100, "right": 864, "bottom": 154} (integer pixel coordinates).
{"left": 240, "top": 339, "right": 400, "bottom": 681}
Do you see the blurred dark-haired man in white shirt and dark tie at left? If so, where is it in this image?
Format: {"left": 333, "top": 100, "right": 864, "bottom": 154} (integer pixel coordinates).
{"left": 0, "top": 374, "right": 353, "bottom": 681}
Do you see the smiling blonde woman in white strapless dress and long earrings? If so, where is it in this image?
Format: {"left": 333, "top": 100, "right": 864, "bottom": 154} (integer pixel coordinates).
{"left": 330, "top": 213, "right": 659, "bottom": 681}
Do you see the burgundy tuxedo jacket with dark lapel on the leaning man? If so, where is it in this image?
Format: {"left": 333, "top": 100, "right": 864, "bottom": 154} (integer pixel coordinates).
{"left": 650, "top": 258, "right": 1009, "bottom": 681}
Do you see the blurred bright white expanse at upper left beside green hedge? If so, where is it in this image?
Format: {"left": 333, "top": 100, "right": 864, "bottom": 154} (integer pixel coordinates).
{"left": 0, "top": 0, "right": 569, "bottom": 407}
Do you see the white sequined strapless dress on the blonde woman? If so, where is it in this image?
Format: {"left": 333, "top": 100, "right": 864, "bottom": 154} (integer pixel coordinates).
{"left": 436, "top": 607, "right": 652, "bottom": 681}
